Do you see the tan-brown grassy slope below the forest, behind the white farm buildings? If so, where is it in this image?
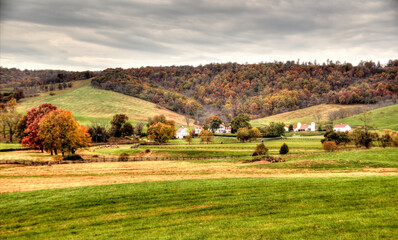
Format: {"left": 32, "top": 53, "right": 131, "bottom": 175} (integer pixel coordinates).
{"left": 251, "top": 104, "right": 367, "bottom": 127}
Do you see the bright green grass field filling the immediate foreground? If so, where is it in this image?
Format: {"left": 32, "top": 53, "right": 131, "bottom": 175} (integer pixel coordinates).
{"left": 0, "top": 177, "right": 398, "bottom": 239}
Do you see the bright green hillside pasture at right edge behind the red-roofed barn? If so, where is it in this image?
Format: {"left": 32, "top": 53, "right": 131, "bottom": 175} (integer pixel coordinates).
{"left": 334, "top": 104, "right": 398, "bottom": 131}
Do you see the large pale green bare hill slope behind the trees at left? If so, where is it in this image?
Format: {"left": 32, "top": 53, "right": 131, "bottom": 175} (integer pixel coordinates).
{"left": 18, "top": 80, "right": 194, "bottom": 126}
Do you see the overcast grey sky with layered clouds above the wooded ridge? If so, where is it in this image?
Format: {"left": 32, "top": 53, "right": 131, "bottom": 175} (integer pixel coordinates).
{"left": 0, "top": 0, "right": 398, "bottom": 71}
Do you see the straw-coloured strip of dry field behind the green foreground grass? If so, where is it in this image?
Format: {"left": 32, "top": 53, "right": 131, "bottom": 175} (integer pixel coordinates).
{"left": 0, "top": 161, "right": 398, "bottom": 193}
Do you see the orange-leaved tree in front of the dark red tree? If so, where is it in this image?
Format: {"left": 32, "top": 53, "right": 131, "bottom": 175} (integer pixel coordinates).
{"left": 38, "top": 109, "right": 91, "bottom": 155}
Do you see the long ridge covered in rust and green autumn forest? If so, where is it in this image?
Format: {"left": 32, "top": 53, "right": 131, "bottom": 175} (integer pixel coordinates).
{"left": 92, "top": 60, "right": 398, "bottom": 121}
